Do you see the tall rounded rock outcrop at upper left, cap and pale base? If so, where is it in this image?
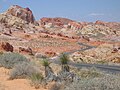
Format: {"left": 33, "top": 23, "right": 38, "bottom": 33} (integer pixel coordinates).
{"left": 0, "top": 5, "right": 38, "bottom": 33}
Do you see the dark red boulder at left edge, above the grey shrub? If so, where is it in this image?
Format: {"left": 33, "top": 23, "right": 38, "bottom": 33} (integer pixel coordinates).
{"left": 0, "top": 42, "right": 13, "bottom": 52}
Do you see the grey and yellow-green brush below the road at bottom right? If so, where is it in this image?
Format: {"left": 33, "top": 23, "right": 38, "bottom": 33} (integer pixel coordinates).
{"left": 51, "top": 68, "right": 120, "bottom": 90}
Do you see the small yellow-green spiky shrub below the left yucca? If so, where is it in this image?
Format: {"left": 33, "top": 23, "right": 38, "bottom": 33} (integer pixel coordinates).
{"left": 29, "top": 73, "right": 44, "bottom": 89}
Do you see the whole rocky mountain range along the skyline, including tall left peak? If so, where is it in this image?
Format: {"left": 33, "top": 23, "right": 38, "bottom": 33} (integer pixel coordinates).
{"left": 0, "top": 5, "right": 120, "bottom": 37}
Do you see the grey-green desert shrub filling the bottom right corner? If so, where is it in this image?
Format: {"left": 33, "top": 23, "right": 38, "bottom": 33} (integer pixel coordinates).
{"left": 64, "top": 74, "right": 120, "bottom": 90}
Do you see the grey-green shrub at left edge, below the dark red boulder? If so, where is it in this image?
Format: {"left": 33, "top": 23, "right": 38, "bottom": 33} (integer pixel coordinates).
{"left": 0, "top": 53, "right": 28, "bottom": 69}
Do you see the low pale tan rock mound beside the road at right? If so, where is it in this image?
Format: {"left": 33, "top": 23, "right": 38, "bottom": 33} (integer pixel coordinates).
{"left": 71, "top": 43, "right": 120, "bottom": 63}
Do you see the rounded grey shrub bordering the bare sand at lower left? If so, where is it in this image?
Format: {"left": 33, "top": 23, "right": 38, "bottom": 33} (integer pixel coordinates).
{"left": 10, "top": 62, "right": 40, "bottom": 79}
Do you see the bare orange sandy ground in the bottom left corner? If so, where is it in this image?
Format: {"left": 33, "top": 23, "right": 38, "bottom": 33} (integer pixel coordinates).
{"left": 0, "top": 68, "right": 47, "bottom": 90}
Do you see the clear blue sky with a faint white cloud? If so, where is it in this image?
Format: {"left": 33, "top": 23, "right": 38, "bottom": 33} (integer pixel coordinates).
{"left": 0, "top": 0, "right": 120, "bottom": 22}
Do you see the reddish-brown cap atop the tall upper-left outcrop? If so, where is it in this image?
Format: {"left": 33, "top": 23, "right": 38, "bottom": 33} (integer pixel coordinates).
{"left": 6, "top": 5, "right": 35, "bottom": 23}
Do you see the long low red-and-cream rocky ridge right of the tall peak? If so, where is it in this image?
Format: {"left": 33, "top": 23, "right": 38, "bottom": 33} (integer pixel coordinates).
{"left": 39, "top": 18, "right": 120, "bottom": 38}
